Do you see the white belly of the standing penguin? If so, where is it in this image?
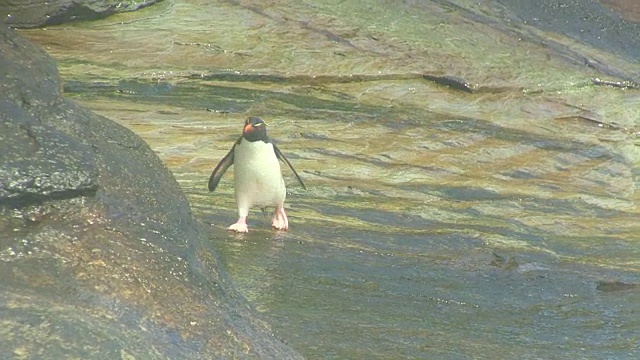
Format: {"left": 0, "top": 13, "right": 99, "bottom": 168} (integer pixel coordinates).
{"left": 233, "top": 139, "right": 286, "bottom": 216}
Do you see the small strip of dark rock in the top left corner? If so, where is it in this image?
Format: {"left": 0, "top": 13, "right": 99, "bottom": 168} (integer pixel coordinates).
{"left": 0, "top": 0, "right": 162, "bottom": 28}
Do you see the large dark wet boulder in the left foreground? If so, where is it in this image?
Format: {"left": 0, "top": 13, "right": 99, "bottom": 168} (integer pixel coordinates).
{"left": 0, "top": 26, "right": 300, "bottom": 359}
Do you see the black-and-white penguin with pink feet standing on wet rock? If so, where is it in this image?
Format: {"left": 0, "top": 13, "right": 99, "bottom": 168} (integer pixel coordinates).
{"left": 209, "top": 117, "right": 307, "bottom": 233}
